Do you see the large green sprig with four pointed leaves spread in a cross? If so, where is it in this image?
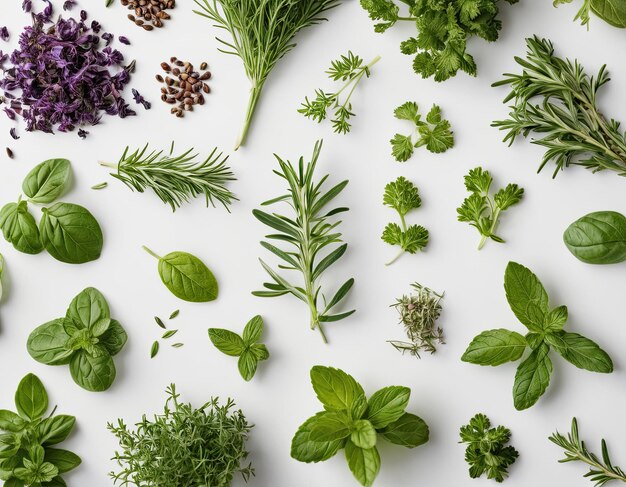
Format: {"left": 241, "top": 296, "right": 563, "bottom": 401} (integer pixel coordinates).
{"left": 462, "top": 262, "right": 613, "bottom": 410}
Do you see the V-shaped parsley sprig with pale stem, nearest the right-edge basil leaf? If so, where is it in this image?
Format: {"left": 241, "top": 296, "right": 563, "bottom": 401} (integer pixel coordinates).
{"left": 456, "top": 167, "right": 524, "bottom": 250}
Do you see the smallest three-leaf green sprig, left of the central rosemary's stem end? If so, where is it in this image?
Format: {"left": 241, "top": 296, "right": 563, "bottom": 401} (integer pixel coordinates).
{"left": 209, "top": 315, "right": 270, "bottom": 381}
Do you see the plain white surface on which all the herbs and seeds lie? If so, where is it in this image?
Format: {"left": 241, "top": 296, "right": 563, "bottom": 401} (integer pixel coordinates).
{"left": 0, "top": 0, "right": 626, "bottom": 487}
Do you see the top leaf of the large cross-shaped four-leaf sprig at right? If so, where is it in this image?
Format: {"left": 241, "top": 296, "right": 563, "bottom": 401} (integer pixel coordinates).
{"left": 504, "top": 262, "right": 549, "bottom": 332}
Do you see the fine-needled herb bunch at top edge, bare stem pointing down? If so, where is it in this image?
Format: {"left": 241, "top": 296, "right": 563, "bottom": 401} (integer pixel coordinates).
{"left": 194, "top": 0, "right": 339, "bottom": 150}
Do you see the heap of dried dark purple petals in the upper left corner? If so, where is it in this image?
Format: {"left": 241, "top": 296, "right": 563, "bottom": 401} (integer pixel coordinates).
{"left": 0, "top": 5, "right": 135, "bottom": 137}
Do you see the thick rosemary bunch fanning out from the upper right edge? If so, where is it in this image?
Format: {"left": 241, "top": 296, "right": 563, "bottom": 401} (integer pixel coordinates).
{"left": 492, "top": 36, "right": 626, "bottom": 177}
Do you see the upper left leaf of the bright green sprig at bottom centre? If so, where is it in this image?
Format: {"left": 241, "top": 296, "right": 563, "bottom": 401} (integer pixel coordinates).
{"left": 311, "top": 365, "right": 365, "bottom": 411}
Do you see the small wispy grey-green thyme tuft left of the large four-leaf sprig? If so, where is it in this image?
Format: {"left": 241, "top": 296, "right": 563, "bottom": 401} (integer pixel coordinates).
{"left": 389, "top": 283, "right": 445, "bottom": 358}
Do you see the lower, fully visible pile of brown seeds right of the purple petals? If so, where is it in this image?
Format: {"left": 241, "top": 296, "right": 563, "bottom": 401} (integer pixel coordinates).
{"left": 156, "top": 57, "right": 211, "bottom": 117}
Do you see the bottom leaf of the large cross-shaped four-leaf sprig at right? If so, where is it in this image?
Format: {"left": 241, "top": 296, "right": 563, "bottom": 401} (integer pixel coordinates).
{"left": 513, "top": 343, "right": 552, "bottom": 411}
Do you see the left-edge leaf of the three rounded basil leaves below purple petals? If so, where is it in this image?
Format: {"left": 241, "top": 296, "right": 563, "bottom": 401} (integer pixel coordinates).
{"left": 0, "top": 201, "right": 43, "bottom": 254}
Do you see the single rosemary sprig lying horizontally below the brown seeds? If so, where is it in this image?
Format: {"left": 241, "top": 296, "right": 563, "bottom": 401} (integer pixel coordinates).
{"left": 100, "top": 143, "right": 237, "bottom": 211}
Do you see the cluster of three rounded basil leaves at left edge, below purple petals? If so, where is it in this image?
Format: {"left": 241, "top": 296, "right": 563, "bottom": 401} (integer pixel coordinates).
{"left": 0, "top": 159, "right": 103, "bottom": 264}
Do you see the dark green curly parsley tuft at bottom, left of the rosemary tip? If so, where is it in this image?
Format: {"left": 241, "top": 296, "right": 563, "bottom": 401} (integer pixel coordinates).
{"left": 461, "top": 414, "right": 519, "bottom": 482}
